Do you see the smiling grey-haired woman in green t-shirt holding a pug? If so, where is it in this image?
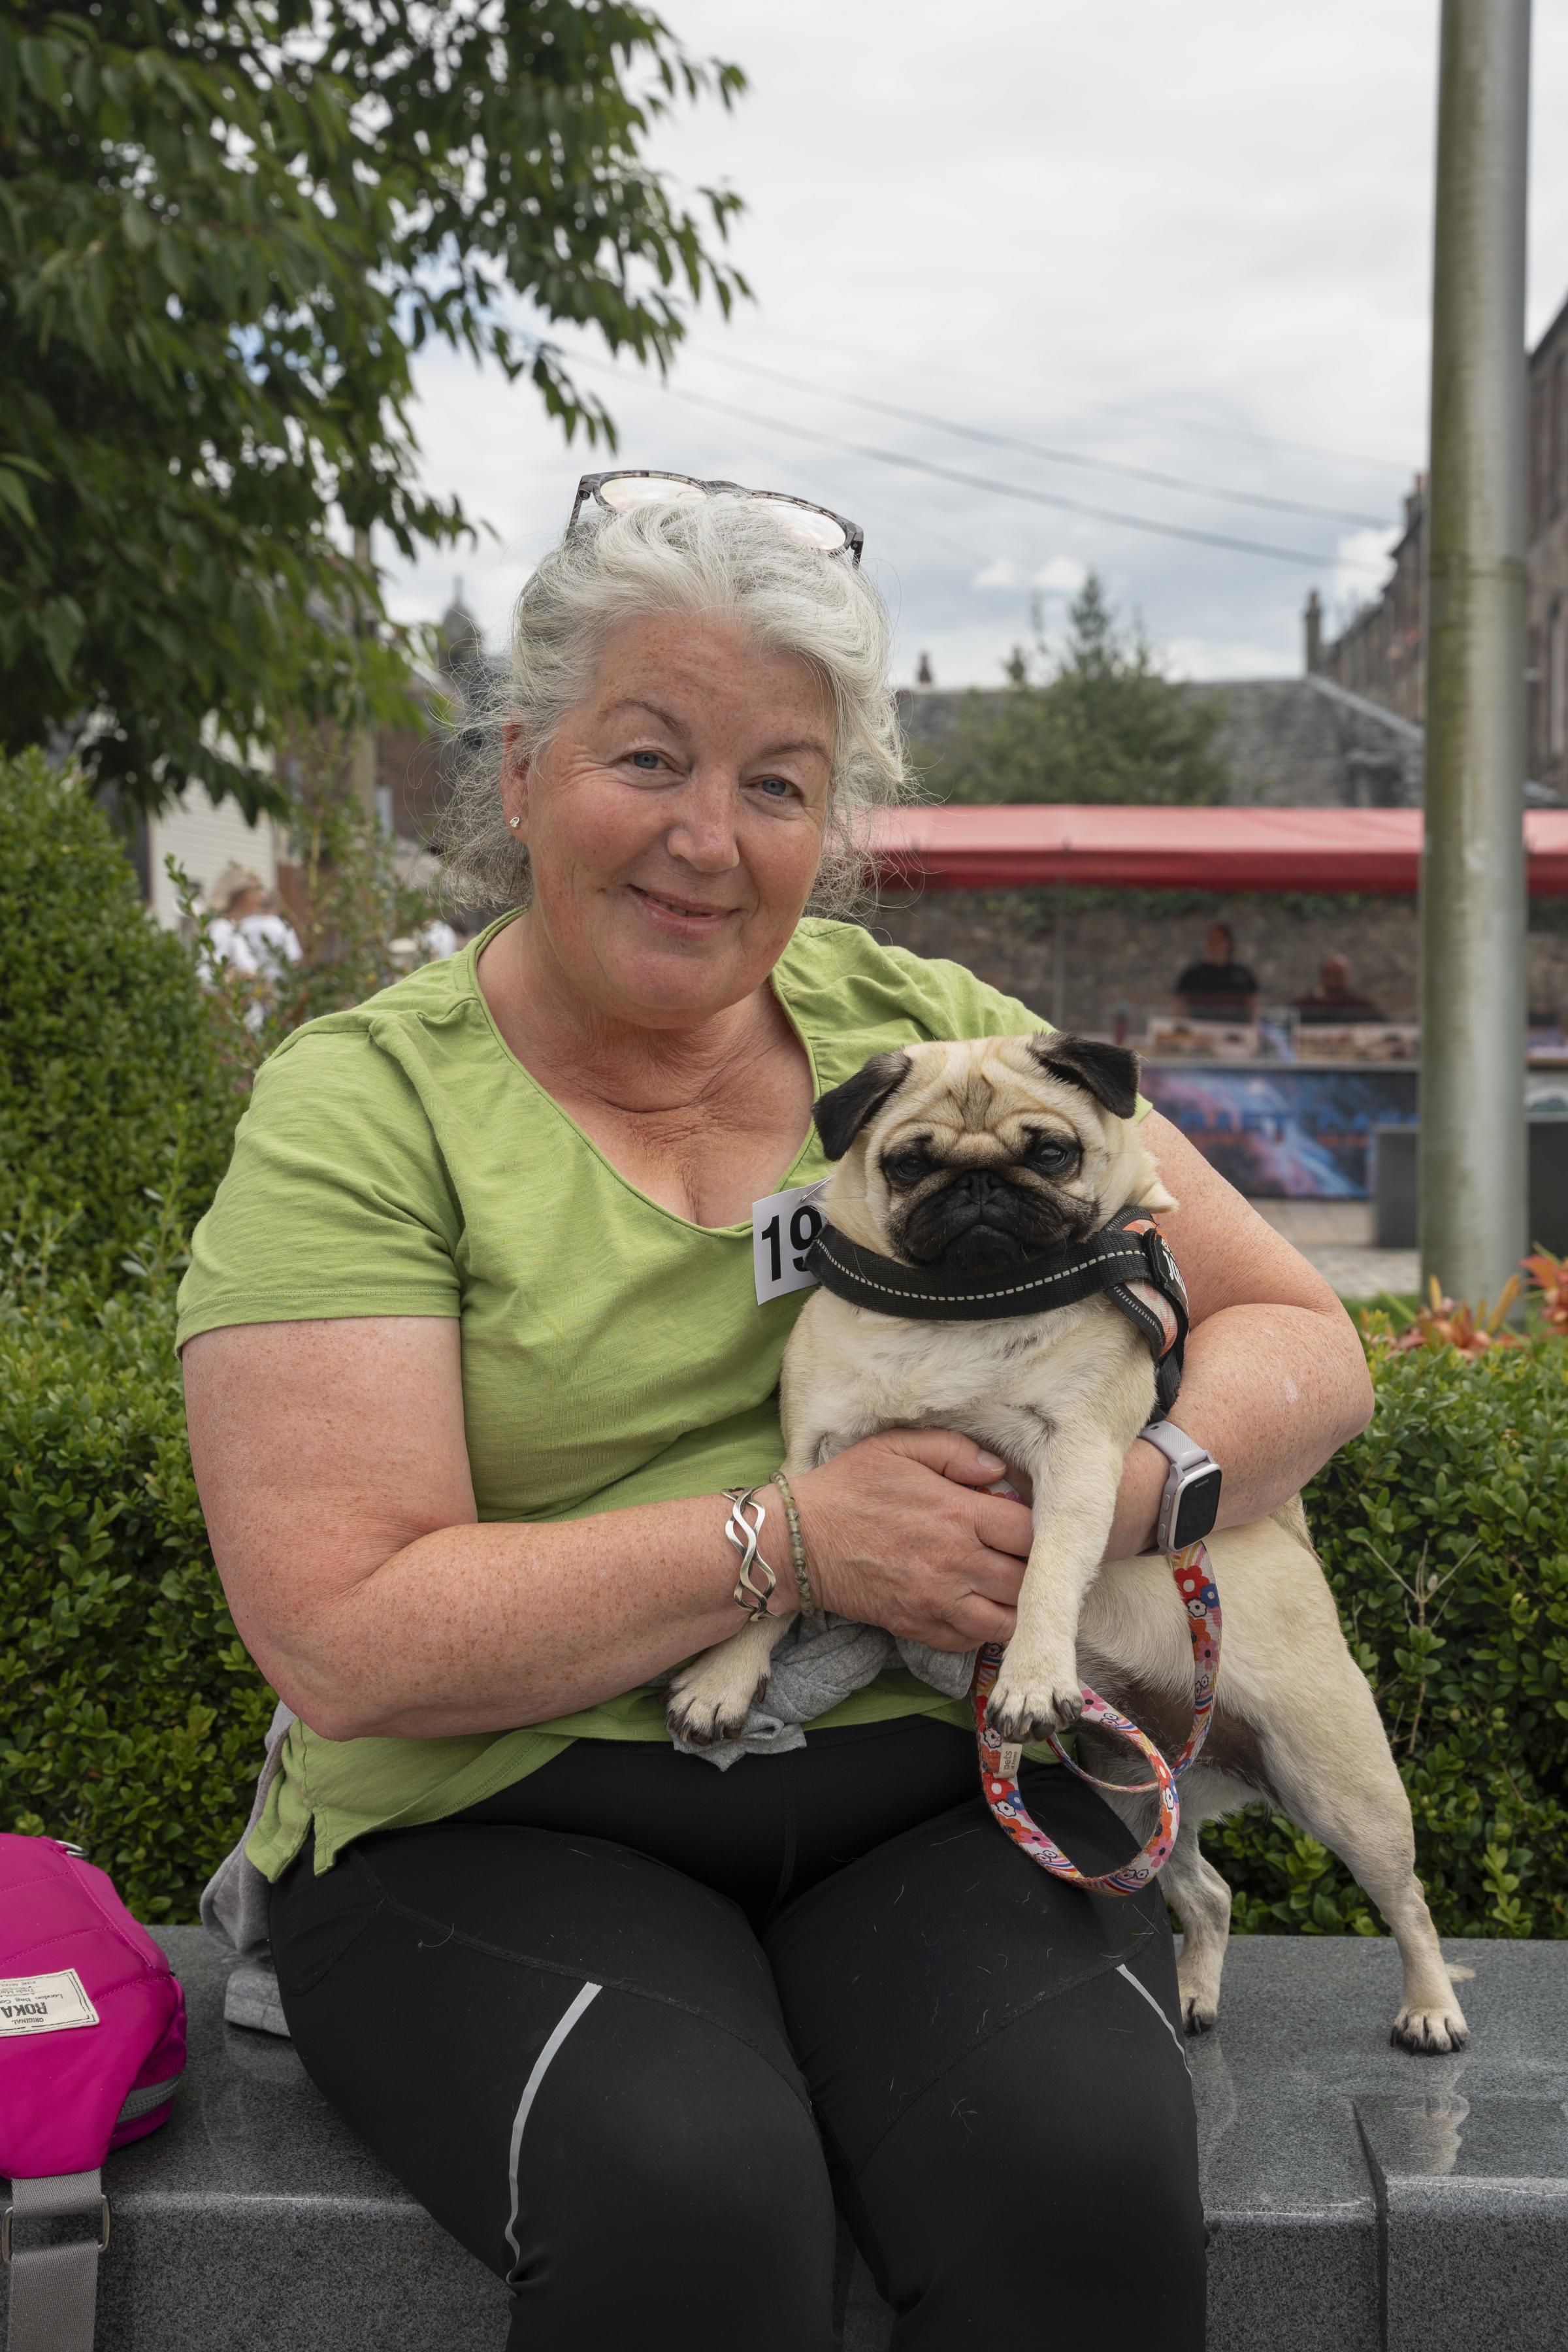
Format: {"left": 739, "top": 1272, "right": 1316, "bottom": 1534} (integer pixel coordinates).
{"left": 178, "top": 473, "right": 1368, "bottom": 2352}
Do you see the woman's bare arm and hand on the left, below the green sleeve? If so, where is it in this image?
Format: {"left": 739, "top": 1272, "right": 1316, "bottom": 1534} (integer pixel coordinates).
{"left": 184, "top": 1315, "right": 1030, "bottom": 1740}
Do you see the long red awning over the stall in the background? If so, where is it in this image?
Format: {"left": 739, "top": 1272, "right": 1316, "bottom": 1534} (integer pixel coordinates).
{"left": 872, "top": 802, "right": 1568, "bottom": 898}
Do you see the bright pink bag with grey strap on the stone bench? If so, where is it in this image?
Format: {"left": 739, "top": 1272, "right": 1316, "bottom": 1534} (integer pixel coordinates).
{"left": 0, "top": 1832, "right": 186, "bottom": 2352}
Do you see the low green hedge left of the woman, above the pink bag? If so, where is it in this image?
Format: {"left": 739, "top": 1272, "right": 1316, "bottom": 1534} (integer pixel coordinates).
{"left": 0, "top": 1286, "right": 272, "bottom": 1919}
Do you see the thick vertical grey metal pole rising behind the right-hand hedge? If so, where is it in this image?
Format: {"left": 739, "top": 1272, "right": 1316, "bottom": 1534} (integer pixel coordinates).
{"left": 1420, "top": 0, "right": 1530, "bottom": 1301}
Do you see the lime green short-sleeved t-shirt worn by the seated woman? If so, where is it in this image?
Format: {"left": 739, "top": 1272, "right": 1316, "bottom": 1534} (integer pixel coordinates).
{"left": 178, "top": 917, "right": 1067, "bottom": 1877}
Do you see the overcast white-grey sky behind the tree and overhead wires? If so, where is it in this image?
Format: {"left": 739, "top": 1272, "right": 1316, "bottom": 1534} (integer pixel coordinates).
{"left": 390, "top": 0, "right": 1568, "bottom": 685}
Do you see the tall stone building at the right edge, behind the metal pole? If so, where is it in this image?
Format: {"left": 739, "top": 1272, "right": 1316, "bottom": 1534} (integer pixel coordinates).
{"left": 1305, "top": 282, "right": 1568, "bottom": 800}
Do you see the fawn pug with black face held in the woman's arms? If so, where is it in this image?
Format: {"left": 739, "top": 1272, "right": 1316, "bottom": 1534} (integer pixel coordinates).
{"left": 668, "top": 1035, "right": 1469, "bottom": 2053}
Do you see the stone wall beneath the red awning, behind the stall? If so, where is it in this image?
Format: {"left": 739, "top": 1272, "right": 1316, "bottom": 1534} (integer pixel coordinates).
{"left": 872, "top": 891, "right": 1568, "bottom": 1032}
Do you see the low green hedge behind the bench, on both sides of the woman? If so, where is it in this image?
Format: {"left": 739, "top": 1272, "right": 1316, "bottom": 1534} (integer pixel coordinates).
{"left": 0, "top": 1289, "right": 1568, "bottom": 1936}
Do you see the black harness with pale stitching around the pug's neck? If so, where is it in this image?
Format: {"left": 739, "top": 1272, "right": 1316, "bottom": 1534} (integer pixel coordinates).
{"left": 806, "top": 1204, "right": 1187, "bottom": 1420}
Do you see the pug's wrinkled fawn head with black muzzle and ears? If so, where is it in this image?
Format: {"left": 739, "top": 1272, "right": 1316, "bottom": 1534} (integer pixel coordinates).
{"left": 816, "top": 1037, "right": 1175, "bottom": 1275}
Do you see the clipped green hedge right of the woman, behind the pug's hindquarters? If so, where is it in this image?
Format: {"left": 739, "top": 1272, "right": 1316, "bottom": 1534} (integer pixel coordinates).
{"left": 1206, "top": 1336, "right": 1568, "bottom": 1936}
